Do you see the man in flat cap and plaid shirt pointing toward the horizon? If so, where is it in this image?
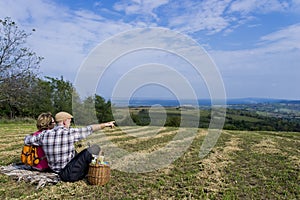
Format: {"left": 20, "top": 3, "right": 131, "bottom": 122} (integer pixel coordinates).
{"left": 24, "top": 112, "right": 115, "bottom": 182}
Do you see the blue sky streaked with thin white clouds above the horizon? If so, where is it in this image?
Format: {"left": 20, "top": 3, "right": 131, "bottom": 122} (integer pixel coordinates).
{"left": 0, "top": 0, "right": 300, "bottom": 99}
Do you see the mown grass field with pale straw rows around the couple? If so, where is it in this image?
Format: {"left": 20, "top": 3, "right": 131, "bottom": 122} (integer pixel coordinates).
{"left": 0, "top": 124, "right": 300, "bottom": 199}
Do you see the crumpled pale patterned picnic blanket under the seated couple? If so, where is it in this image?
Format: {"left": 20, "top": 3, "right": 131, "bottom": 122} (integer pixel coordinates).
{"left": 0, "top": 163, "right": 60, "bottom": 189}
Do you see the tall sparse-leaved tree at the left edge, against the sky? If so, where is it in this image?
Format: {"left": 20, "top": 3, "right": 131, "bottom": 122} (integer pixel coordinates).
{"left": 0, "top": 17, "right": 42, "bottom": 118}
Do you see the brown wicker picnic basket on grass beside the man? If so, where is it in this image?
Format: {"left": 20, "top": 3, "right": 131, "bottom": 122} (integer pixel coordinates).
{"left": 88, "top": 164, "right": 110, "bottom": 185}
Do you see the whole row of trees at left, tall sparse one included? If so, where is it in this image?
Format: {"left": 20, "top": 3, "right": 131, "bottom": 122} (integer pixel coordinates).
{"left": 0, "top": 17, "right": 112, "bottom": 124}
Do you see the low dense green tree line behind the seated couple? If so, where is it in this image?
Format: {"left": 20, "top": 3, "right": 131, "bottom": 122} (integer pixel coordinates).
{"left": 0, "top": 77, "right": 113, "bottom": 124}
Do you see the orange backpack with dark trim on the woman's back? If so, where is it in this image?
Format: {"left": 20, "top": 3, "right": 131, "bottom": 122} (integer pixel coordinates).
{"left": 21, "top": 145, "right": 40, "bottom": 166}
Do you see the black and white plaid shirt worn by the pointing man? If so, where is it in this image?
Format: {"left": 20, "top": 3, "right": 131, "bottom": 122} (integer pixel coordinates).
{"left": 24, "top": 126, "right": 93, "bottom": 173}
